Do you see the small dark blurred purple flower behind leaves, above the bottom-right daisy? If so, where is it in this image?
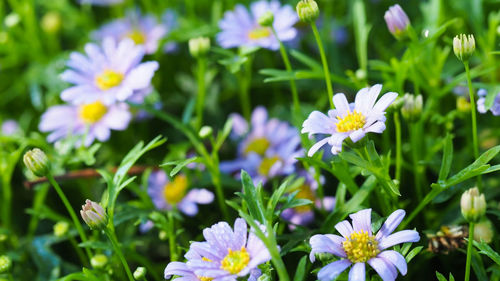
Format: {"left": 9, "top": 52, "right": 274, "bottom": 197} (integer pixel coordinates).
{"left": 281, "top": 170, "right": 335, "bottom": 229}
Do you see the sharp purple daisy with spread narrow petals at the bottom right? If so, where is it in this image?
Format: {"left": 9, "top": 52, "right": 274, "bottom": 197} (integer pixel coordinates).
{"left": 309, "top": 209, "right": 420, "bottom": 281}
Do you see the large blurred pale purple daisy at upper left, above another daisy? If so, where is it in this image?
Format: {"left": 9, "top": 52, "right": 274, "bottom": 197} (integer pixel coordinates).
{"left": 61, "top": 37, "right": 158, "bottom": 104}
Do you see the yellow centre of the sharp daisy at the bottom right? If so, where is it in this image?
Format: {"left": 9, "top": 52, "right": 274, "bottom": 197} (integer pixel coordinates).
{"left": 342, "top": 230, "right": 380, "bottom": 263}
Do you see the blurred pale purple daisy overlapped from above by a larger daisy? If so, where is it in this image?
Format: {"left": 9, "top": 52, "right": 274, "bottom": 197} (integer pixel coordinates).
{"left": 38, "top": 101, "right": 132, "bottom": 146}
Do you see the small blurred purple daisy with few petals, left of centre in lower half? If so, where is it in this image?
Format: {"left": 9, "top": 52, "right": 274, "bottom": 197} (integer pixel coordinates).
{"left": 148, "top": 170, "right": 214, "bottom": 216}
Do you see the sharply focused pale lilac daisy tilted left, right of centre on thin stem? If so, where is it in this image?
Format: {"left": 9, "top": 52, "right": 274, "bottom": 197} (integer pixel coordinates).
{"left": 301, "top": 84, "right": 398, "bottom": 156}
